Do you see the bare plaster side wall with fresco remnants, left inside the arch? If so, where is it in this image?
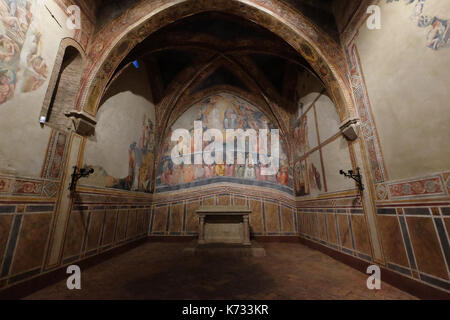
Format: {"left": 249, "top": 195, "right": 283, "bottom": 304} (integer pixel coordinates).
{"left": 82, "top": 65, "right": 155, "bottom": 191}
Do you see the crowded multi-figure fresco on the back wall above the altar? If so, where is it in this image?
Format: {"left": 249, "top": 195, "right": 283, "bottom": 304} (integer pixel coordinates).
{"left": 156, "top": 93, "right": 293, "bottom": 193}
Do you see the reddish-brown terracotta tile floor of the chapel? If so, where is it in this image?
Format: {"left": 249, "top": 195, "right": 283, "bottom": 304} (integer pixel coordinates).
{"left": 27, "top": 242, "right": 414, "bottom": 300}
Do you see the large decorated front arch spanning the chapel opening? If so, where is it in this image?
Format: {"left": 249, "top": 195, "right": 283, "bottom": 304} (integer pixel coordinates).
{"left": 77, "top": 0, "right": 355, "bottom": 120}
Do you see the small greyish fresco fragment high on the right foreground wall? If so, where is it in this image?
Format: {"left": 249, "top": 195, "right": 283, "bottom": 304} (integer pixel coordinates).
{"left": 387, "top": 0, "right": 450, "bottom": 50}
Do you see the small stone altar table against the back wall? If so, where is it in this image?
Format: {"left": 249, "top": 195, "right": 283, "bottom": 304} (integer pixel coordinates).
{"left": 197, "top": 206, "right": 252, "bottom": 246}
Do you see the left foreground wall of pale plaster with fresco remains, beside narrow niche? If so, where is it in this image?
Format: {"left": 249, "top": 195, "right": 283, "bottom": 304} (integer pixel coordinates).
{"left": 0, "top": 0, "right": 92, "bottom": 177}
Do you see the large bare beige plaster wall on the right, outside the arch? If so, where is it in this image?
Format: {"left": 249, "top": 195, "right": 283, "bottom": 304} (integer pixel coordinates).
{"left": 356, "top": 0, "right": 450, "bottom": 180}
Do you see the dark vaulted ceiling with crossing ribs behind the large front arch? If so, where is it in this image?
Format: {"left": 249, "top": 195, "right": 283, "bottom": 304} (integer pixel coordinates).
{"left": 107, "top": 12, "right": 322, "bottom": 125}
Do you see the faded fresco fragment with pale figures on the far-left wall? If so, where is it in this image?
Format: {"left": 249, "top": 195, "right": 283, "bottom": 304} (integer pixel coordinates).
{"left": 0, "top": 0, "right": 48, "bottom": 104}
